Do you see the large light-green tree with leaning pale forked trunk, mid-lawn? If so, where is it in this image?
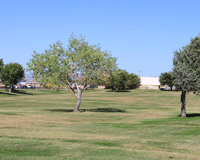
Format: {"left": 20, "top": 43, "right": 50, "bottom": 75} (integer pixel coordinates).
{"left": 27, "top": 34, "right": 116, "bottom": 112}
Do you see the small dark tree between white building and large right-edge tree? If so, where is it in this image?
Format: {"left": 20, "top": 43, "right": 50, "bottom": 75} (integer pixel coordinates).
{"left": 159, "top": 72, "right": 174, "bottom": 91}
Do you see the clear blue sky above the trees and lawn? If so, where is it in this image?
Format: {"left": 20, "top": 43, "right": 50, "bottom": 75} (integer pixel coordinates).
{"left": 0, "top": 0, "right": 200, "bottom": 76}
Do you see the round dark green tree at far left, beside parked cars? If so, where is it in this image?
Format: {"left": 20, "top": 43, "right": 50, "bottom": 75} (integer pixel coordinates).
{"left": 1, "top": 63, "right": 24, "bottom": 92}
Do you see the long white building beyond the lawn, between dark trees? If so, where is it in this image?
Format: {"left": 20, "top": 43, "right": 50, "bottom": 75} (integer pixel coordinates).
{"left": 140, "top": 77, "right": 160, "bottom": 89}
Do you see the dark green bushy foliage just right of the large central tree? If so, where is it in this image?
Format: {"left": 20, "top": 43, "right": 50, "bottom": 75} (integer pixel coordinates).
{"left": 106, "top": 69, "right": 140, "bottom": 91}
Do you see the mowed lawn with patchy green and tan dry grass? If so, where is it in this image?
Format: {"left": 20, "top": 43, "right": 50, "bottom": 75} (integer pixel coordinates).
{"left": 0, "top": 89, "right": 200, "bottom": 160}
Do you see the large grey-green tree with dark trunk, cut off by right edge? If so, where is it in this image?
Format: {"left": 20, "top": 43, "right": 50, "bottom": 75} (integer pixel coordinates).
{"left": 172, "top": 36, "right": 200, "bottom": 117}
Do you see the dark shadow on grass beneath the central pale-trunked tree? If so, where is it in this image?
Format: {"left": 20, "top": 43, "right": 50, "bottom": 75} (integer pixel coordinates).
{"left": 46, "top": 108, "right": 125, "bottom": 113}
